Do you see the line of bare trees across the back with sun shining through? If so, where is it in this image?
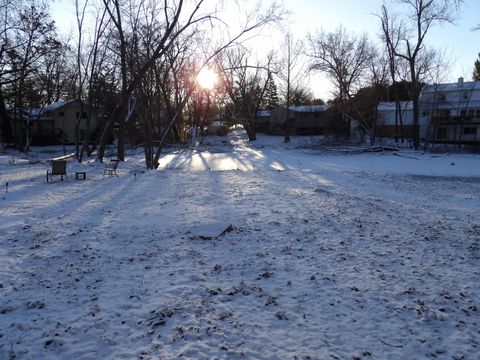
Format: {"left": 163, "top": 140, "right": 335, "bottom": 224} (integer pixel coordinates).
{"left": 0, "top": 0, "right": 459, "bottom": 168}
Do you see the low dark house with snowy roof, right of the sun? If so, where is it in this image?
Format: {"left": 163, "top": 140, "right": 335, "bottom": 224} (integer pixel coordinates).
{"left": 270, "top": 105, "right": 346, "bottom": 136}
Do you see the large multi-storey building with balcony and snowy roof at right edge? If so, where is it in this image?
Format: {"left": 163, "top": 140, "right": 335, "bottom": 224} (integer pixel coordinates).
{"left": 376, "top": 78, "right": 480, "bottom": 144}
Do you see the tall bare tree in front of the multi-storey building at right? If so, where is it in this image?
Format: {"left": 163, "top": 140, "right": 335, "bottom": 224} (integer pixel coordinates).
{"left": 381, "top": 0, "right": 462, "bottom": 149}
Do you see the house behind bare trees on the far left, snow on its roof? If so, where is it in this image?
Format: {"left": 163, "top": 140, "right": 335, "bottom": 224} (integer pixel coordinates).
{"left": 10, "top": 100, "right": 101, "bottom": 146}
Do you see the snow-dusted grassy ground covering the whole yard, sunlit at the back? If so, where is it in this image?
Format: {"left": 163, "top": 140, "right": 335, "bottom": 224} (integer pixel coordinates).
{"left": 0, "top": 133, "right": 480, "bottom": 359}
